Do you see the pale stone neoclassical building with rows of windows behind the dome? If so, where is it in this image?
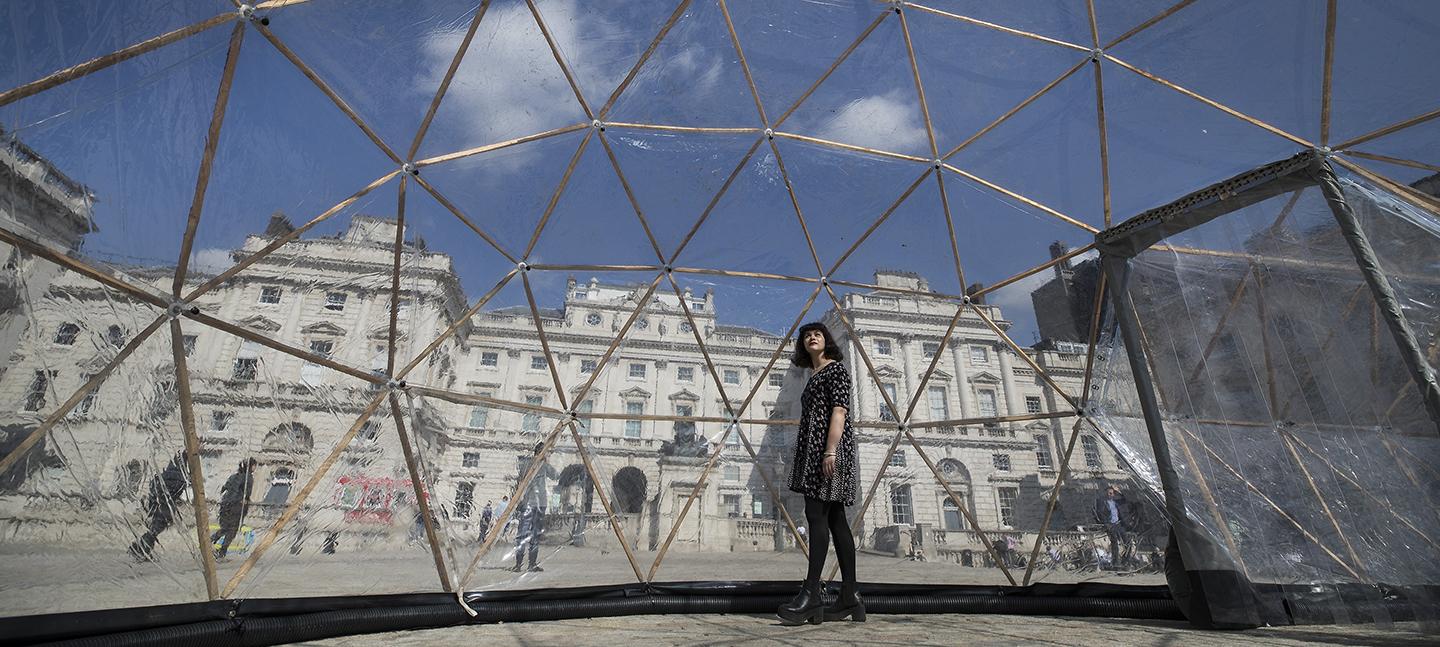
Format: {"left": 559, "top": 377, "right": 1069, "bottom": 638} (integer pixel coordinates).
{"left": 0, "top": 147, "right": 1126, "bottom": 550}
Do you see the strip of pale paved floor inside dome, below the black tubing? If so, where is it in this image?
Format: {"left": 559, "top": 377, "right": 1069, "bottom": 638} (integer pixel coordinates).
{"left": 298, "top": 615, "right": 1440, "bottom": 647}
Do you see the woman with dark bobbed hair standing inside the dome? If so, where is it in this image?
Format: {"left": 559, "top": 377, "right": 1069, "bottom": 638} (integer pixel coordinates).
{"left": 776, "top": 323, "right": 865, "bottom": 625}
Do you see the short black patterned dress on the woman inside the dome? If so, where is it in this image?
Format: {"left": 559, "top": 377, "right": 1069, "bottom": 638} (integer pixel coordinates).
{"left": 789, "top": 362, "right": 858, "bottom": 506}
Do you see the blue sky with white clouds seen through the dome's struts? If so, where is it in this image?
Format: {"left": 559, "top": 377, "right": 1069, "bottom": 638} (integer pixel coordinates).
{"left": 0, "top": 0, "right": 1440, "bottom": 343}
